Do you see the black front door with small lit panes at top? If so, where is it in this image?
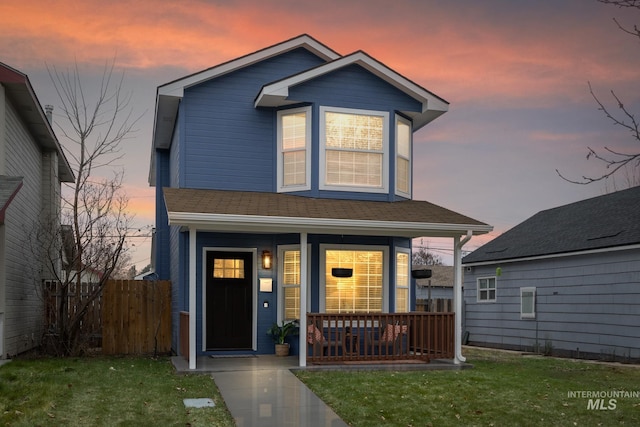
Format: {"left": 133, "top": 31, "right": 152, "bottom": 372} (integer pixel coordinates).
{"left": 205, "top": 251, "right": 253, "bottom": 350}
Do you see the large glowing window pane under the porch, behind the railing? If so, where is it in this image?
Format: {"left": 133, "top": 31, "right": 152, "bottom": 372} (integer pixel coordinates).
{"left": 321, "top": 249, "right": 385, "bottom": 313}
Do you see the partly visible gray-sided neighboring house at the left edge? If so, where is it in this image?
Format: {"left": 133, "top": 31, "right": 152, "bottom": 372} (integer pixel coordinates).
{"left": 0, "top": 63, "right": 73, "bottom": 358}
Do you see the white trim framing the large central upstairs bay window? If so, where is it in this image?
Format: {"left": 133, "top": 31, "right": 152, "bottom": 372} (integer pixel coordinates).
{"left": 318, "top": 106, "right": 389, "bottom": 193}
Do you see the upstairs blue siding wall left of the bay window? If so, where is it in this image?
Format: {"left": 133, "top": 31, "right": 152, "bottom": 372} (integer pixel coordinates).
{"left": 181, "top": 49, "right": 322, "bottom": 191}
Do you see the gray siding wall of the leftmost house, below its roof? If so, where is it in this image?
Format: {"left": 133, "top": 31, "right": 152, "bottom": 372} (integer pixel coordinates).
{"left": 3, "top": 98, "right": 43, "bottom": 355}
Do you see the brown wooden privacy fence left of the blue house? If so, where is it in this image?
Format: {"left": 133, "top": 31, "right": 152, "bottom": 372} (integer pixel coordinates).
{"left": 44, "top": 280, "right": 171, "bottom": 354}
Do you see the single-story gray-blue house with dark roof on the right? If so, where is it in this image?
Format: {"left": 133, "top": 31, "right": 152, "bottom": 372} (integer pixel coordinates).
{"left": 463, "top": 187, "right": 640, "bottom": 361}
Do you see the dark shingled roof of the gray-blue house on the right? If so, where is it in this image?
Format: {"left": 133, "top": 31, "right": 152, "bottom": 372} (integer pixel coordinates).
{"left": 462, "top": 186, "right": 640, "bottom": 265}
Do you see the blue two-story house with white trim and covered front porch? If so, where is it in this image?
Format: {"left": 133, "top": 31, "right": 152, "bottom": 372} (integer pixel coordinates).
{"left": 150, "top": 35, "right": 492, "bottom": 369}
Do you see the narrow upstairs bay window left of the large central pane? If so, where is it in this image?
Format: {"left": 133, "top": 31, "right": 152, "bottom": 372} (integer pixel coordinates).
{"left": 278, "top": 107, "right": 311, "bottom": 191}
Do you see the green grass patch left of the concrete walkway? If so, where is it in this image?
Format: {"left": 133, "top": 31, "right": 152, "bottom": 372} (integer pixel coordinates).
{"left": 0, "top": 357, "right": 233, "bottom": 426}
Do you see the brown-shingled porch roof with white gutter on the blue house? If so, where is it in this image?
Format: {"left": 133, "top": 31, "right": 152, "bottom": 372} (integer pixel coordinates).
{"left": 163, "top": 187, "right": 493, "bottom": 237}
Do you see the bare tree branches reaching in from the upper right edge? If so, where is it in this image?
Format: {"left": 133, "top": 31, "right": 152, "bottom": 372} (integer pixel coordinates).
{"left": 556, "top": 0, "right": 640, "bottom": 186}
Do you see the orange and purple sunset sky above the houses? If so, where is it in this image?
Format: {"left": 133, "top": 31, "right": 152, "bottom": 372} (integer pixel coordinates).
{"left": 0, "top": 0, "right": 640, "bottom": 268}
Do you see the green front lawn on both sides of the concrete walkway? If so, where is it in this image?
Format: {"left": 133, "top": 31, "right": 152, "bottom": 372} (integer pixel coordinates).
{"left": 0, "top": 349, "right": 640, "bottom": 427}
